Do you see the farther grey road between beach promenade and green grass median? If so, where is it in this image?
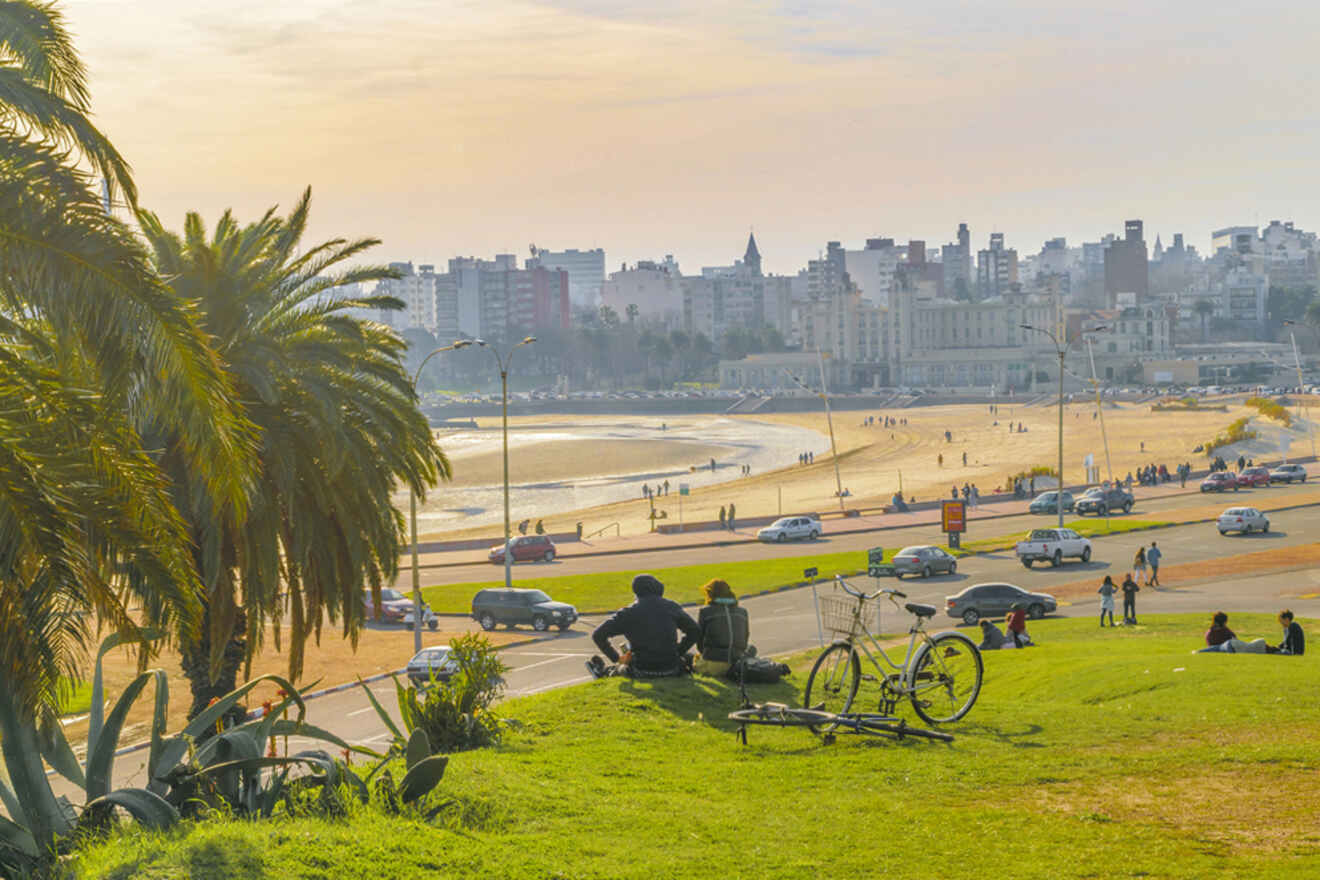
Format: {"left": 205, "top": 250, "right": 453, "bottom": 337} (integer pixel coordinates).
{"left": 421, "top": 484, "right": 1312, "bottom": 587}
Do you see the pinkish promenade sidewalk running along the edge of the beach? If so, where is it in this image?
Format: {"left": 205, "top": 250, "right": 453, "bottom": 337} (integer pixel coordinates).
{"left": 414, "top": 458, "right": 1320, "bottom": 570}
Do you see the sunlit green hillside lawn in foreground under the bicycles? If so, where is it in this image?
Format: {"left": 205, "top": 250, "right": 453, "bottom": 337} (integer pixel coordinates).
{"left": 69, "top": 615, "right": 1320, "bottom": 880}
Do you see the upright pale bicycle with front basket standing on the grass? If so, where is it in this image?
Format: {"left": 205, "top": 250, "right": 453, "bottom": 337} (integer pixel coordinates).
{"left": 803, "top": 575, "right": 983, "bottom": 731}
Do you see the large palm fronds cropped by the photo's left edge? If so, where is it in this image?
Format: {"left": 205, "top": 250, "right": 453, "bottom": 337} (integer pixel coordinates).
{"left": 0, "top": 0, "right": 247, "bottom": 728}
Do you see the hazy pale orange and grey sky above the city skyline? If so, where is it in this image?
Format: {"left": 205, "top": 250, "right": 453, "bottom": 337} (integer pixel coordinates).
{"left": 63, "top": 0, "right": 1320, "bottom": 272}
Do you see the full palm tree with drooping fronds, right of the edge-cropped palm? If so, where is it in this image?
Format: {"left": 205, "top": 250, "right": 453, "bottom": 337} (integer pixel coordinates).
{"left": 140, "top": 189, "right": 449, "bottom": 714}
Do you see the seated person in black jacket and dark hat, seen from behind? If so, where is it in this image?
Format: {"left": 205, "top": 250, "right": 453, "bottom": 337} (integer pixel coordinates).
{"left": 587, "top": 574, "right": 701, "bottom": 678}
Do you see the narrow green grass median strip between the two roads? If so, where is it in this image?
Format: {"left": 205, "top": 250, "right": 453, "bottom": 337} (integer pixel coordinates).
{"left": 422, "top": 519, "right": 1172, "bottom": 613}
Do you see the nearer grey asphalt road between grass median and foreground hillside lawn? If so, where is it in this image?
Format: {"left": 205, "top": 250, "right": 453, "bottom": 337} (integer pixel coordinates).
{"left": 62, "top": 499, "right": 1320, "bottom": 785}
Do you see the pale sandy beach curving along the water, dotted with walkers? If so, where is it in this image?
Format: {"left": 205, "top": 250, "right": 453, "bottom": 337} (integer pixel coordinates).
{"left": 409, "top": 400, "right": 1311, "bottom": 540}
